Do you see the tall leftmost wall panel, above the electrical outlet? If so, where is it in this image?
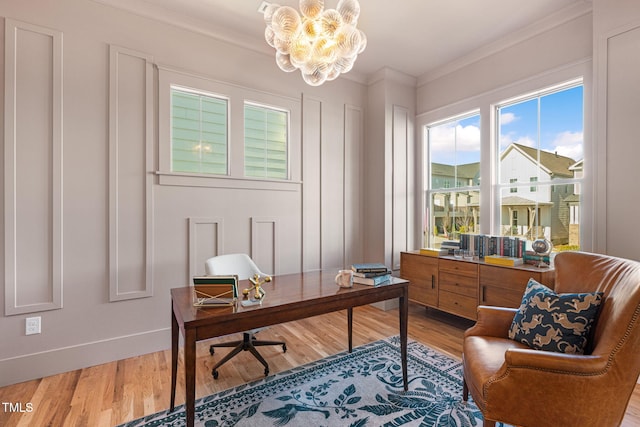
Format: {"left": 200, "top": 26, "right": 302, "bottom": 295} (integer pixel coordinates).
{"left": 4, "top": 19, "right": 63, "bottom": 315}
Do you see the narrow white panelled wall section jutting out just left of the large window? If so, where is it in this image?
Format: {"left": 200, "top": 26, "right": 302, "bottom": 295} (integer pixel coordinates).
{"left": 363, "top": 68, "right": 416, "bottom": 270}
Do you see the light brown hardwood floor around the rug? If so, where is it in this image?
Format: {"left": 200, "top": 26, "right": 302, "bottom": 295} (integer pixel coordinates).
{"left": 0, "top": 304, "right": 640, "bottom": 427}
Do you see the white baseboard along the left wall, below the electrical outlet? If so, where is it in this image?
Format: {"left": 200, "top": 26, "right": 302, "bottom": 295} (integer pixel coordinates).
{"left": 0, "top": 328, "right": 171, "bottom": 387}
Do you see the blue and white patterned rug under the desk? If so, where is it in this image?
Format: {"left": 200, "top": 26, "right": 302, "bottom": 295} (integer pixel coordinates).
{"left": 123, "top": 337, "right": 482, "bottom": 427}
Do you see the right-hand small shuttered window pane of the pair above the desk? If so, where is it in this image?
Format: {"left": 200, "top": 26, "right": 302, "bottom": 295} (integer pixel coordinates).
{"left": 244, "top": 103, "right": 289, "bottom": 179}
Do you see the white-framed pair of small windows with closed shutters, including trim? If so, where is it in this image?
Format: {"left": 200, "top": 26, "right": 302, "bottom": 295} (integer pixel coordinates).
{"left": 156, "top": 66, "right": 302, "bottom": 191}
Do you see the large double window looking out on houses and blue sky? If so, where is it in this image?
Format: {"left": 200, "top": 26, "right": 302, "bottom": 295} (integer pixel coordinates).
{"left": 421, "top": 78, "right": 590, "bottom": 250}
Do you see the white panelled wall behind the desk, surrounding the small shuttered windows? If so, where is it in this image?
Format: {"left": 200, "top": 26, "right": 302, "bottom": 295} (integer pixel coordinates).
{"left": 0, "top": 0, "right": 367, "bottom": 386}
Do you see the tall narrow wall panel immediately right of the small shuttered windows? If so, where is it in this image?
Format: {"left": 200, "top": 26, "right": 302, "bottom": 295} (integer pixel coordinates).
{"left": 302, "top": 97, "right": 322, "bottom": 271}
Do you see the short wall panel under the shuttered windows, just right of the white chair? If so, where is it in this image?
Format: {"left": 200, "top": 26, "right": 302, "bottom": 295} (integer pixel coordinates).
{"left": 251, "top": 217, "right": 280, "bottom": 275}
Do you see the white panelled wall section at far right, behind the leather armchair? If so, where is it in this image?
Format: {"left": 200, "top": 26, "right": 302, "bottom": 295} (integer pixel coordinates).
{"left": 593, "top": 0, "right": 640, "bottom": 260}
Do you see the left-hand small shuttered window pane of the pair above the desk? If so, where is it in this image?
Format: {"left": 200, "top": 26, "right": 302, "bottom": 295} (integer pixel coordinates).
{"left": 171, "top": 87, "right": 228, "bottom": 175}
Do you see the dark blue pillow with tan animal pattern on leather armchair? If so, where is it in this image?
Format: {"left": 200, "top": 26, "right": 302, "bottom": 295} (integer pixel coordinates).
{"left": 509, "top": 279, "right": 602, "bottom": 354}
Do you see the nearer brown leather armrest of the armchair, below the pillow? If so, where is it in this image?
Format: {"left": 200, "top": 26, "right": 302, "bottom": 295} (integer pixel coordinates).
{"left": 504, "top": 348, "right": 608, "bottom": 375}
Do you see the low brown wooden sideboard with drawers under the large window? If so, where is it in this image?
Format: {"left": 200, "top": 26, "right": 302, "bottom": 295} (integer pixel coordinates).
{"left": 400, "top": 252, "right": 555, "bottom": 320}
